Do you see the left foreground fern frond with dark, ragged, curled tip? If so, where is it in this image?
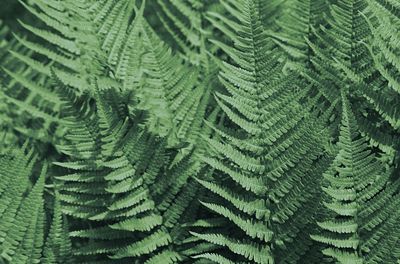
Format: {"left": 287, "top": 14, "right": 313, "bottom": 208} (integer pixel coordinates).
{"left": 53, "top": 83, "right": 166, "bottom": 262}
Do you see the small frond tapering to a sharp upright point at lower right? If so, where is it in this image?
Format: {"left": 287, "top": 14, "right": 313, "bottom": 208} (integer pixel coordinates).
{"left": 312, "top": 92, "right": 398, "bottom": 263}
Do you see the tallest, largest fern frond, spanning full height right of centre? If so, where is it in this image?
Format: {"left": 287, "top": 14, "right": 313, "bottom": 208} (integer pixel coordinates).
{"left": 194, "top": 1, "right": 326, "bottom": 263}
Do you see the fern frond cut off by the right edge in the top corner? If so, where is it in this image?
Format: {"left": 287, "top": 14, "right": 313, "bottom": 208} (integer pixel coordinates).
{"left": 363, "top": 1, "right": 400, "bottom": 153}
